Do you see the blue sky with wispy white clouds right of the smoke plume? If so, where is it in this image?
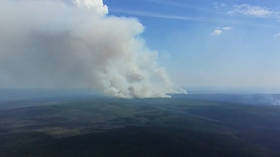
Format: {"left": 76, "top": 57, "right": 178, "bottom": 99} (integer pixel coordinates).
{"left": 104, "top": 0, "right": 280, "bottom": 91}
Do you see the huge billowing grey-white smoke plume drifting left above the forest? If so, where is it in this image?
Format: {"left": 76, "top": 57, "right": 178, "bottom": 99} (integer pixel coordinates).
{"left": 0, "top": 0, "right": 179, "bottom": 98}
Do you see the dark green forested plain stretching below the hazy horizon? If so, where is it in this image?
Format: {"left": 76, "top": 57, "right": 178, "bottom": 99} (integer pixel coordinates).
{"left": 0, "top": 94, "right": 280, "bottom": 157}
